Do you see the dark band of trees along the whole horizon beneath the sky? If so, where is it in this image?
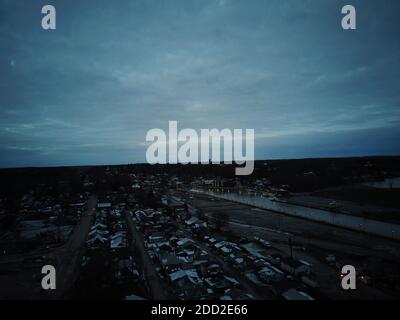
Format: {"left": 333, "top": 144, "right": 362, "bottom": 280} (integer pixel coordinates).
{"left": 0, "top": 157, "right": 400, "bottom": 199}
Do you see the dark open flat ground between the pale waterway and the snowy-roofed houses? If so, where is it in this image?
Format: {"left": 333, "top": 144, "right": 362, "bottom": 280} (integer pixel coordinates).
{"left": 172, "top": 193, "right": 400, "bottom": 299}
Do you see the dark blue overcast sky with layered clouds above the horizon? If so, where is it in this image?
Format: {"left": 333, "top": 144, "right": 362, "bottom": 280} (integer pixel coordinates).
{"left": 0, "top": 0, "right": 400, "bottom": 167}
